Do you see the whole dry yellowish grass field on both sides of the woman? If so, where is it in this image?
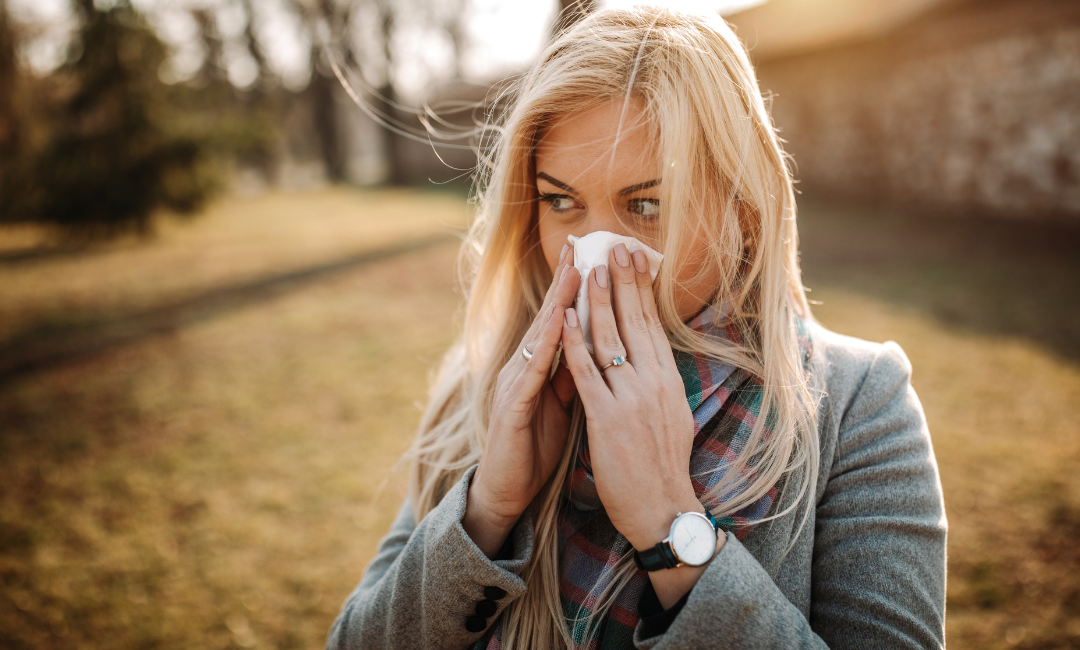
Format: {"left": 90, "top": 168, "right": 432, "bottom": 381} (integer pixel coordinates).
{"left": 0, "top": 184, "right": 1080, "bottom": 650}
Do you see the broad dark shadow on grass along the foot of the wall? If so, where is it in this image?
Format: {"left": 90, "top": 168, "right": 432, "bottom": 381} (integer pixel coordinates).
{"left": 799, "top": 202, "right": 1080, "bottom": 361}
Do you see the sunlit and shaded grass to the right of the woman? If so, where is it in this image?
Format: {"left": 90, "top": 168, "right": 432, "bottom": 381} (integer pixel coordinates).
{"left": 802, "top": 200, "right": 1080, "bottom": 649}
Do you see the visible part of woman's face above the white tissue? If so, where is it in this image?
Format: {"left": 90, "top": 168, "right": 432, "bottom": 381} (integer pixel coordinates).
{"left": 536, "top": 100, "right": 718, "bottom": 321}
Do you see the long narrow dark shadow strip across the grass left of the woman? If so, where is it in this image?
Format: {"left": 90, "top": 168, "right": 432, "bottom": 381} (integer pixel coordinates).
{"left": 0, "top": 234, "right": 451, "bottom": 385}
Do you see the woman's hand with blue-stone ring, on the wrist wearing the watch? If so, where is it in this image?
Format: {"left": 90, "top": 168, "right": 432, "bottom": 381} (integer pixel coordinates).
{"left": 563, "top": 244, "right": 721, "bottom": 607}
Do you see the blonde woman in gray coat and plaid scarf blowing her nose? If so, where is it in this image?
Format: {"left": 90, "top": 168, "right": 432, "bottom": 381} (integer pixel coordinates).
{"left": 328, "top": 9, "right": 946, "bottom": 649}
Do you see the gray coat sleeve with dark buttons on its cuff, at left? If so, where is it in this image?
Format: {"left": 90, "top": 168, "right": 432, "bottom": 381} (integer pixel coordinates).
{"left": 326, "top": 466, "right": 532, "bottom": 650}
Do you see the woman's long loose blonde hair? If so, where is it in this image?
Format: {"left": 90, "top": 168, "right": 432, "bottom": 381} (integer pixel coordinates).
{"left": 410, "top": 8, "right": 818, "bottom": 648}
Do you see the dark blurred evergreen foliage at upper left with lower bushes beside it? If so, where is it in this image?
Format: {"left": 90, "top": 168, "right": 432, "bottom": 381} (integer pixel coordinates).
{"left": 0, "top": 0, "right": 274, "bottom": 240}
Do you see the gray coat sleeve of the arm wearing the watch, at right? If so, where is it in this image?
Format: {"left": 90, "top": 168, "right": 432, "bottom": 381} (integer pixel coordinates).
{"left": 634, "top": 343, "right": 946, "bottom": 650}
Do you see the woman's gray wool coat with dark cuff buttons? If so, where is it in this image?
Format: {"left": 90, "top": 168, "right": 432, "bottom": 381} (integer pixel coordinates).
{"left": 327, "top": 325, "right": 946, "bottom": 650}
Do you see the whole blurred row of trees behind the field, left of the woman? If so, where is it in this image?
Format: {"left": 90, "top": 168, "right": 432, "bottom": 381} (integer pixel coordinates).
{"left": 0, "top": 0, "right": 578, "bottom": 237}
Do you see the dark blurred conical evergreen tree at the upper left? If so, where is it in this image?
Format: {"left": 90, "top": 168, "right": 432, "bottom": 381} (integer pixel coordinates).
{"left": 0, "top": 0, "right": 214, "bottom": 236}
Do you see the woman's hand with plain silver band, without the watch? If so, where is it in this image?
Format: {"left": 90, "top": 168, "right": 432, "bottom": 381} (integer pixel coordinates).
{"left": 461, "top": 246, "right": 580, "bottom": 557}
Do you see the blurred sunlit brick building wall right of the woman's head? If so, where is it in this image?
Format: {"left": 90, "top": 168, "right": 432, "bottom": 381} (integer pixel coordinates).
{"left": 757, "top": 0, "right": 1080, "bottom": 222}
